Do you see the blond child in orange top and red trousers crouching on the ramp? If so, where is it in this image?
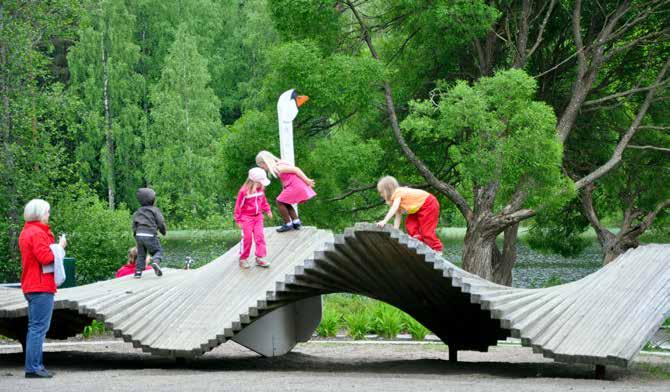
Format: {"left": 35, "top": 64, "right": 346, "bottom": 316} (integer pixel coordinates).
{"left": 377, "top": 176, "right": 442, "bottom": 253}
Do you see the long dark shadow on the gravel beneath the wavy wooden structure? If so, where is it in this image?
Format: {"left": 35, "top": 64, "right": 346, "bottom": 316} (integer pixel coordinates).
{"left": 0, "top": 351, "right": 636, "bottom": 380}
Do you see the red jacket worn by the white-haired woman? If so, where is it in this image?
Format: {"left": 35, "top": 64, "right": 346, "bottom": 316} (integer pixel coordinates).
{"left": 19, "top": 221, "right": 56, "bottom": 293}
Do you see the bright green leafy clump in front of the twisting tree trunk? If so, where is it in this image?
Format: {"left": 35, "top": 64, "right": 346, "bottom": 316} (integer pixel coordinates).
{"left": 402, "top": 70, "right": 569, "bottom": 211}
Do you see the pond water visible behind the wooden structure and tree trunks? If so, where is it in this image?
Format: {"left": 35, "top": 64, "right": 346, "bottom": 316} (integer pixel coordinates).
{"left": 163, "top": 232, "right": 602, "bottom": 288}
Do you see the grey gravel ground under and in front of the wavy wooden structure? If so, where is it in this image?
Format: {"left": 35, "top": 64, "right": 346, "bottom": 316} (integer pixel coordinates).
{"left": 0, "top": 340, "right": 670, "bottom": 392}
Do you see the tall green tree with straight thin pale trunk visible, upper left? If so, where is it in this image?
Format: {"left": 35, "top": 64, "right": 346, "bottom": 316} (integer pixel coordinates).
{"left": 68, "top": 0, "right": 146, "bottom": 209}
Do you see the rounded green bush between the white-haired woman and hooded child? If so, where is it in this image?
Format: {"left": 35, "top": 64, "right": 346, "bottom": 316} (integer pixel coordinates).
{"left": 51, "top": 185, "right": 134, "bottom": 285}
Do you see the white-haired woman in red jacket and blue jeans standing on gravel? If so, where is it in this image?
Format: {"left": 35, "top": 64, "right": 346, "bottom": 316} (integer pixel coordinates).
{"left": 19, "top": 199, "right": 67, "bottom": 378}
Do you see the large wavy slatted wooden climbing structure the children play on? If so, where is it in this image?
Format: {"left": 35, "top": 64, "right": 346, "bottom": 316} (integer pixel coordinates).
{"left": 0, "top": 224, "right": 670, "bottom": 366}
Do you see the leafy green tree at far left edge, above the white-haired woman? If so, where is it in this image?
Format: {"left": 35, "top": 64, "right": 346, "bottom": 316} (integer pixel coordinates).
{"left": 0, "top": 0, "right": 79, "bottom": 276}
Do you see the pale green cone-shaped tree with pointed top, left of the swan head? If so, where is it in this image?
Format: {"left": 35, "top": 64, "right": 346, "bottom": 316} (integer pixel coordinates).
{"left": 143, "top": 25, "right": 223, "bottom": 224}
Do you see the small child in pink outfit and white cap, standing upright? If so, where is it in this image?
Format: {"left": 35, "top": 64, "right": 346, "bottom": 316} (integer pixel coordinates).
{"left": 234, "top": 167, "right": 272, "bottom": 268}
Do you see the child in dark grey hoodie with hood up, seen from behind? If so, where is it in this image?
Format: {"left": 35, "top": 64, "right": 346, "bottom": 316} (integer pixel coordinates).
{"left": 133, "top": 188, "right": 167, "bottom": 279}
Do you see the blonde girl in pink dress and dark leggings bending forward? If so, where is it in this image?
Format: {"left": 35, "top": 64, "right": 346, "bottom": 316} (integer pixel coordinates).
{"left": 256, "top": 151, "right": 316, "bottom": 233}
